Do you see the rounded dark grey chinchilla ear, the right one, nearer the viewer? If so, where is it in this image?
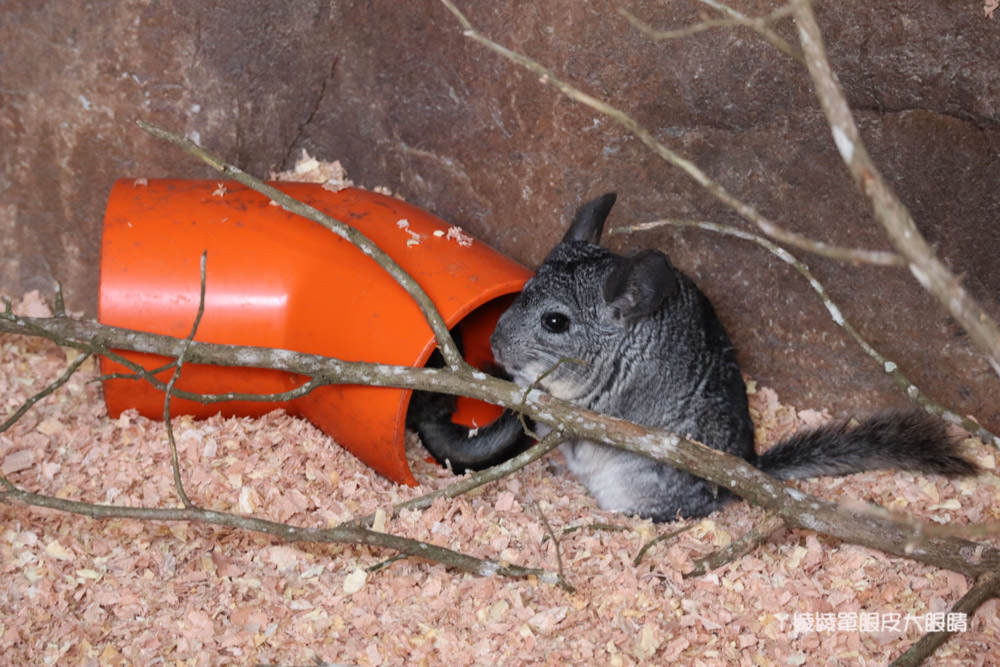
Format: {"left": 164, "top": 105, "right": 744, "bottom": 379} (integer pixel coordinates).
{"left": 604, "top": 250, "right": 678, "bottom": 320}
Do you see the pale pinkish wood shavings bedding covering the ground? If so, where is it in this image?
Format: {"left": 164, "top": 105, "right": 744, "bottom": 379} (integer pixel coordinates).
{"left": 0, "top": 294, "right": 1000, "bottom": 665}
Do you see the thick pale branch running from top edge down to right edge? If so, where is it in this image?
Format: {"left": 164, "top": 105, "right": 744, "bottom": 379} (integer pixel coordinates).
{"left": 792, "top": 0, "right": 1000, "bottom": 375}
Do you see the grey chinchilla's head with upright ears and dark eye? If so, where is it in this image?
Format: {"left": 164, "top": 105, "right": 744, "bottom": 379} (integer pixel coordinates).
{"left": 491, "top": 193, "right": 679, "bottom": 404}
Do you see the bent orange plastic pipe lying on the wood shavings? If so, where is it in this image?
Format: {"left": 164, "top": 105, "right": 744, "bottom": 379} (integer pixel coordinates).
{"left": 99, "top": 180, "right": 531, "bottom": 485}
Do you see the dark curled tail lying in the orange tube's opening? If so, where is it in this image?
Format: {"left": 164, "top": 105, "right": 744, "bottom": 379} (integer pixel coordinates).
{"left": 414, "top": 410, "right": 531, "bottom": 474}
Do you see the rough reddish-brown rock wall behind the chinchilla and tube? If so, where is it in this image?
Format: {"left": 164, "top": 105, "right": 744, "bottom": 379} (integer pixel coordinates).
{"left": 0, "top": 0, "right": 1000, "bottom": 428}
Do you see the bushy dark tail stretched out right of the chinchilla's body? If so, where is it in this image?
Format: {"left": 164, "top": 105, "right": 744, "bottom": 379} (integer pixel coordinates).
{"left": 756, "top": 411, "right": 979, "bottom": 479}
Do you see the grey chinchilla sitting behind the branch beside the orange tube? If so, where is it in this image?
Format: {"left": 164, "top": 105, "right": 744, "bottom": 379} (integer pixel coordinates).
{"left": 404, "top": 193, "right": 978, "bottom": 521}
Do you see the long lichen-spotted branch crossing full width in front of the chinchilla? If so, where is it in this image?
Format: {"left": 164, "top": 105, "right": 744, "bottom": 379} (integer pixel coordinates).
{"left": 0, "top": 314, "right": 1000, "bottom": 576}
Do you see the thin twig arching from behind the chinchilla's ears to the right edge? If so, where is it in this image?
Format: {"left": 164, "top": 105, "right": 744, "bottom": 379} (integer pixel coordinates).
{"left": 608, "top": 219, "right": 1000, "bottom": 447}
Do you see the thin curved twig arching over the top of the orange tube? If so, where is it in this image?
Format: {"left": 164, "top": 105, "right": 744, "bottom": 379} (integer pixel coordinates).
{"left": 137, "top": 120, "right": 468, "bottom": 370}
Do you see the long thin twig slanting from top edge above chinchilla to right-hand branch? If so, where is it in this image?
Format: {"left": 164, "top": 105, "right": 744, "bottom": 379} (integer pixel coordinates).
{"left": 441, "top": 0, "right": 904, "bottom": 266}
